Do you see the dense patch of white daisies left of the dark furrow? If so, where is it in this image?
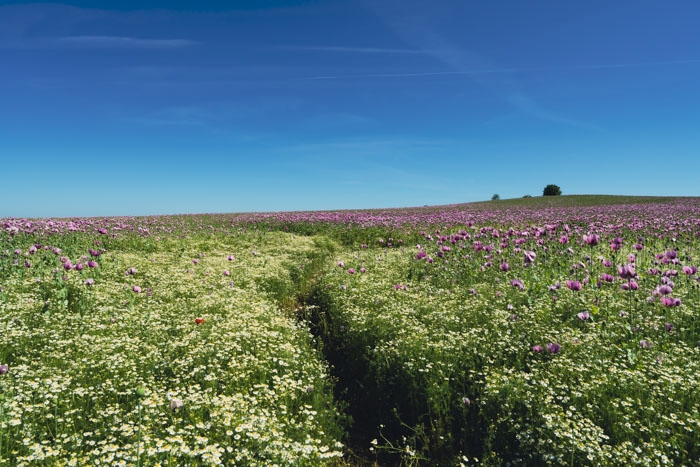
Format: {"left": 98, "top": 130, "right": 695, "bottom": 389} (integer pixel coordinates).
{"left": 0, "top": 229, "right": 342, "bottom": 465}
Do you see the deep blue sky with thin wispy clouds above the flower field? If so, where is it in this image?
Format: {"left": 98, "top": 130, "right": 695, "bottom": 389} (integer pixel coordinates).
{"left": 0, "top": 0, "right": 700, "bottom": 217}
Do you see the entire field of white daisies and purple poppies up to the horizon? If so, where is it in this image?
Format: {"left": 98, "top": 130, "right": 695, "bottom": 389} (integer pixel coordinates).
{"left": 0, "top": 197, "right": 700, "bottom": 466}
